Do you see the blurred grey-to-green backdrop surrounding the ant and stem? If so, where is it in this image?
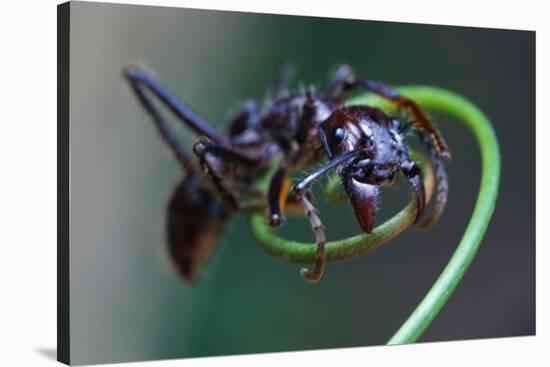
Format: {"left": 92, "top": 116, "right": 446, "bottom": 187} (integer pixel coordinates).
{"left": 70, "top": 2, "right": 535, "bottom": 364}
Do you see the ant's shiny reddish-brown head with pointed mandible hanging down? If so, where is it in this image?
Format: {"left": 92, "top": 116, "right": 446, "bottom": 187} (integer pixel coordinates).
{"left": 319, "top": 106, "right": 407, "bottom": 233}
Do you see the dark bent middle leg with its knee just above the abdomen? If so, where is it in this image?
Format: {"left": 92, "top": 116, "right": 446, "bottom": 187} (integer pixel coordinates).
{"left": 193, "top": 141, "right": 265, "bottom": 211}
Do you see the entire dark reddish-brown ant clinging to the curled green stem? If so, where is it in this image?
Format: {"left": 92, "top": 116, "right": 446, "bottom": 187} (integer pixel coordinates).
{"left": 123, "top": 65, "right": 450, "bottom": 282}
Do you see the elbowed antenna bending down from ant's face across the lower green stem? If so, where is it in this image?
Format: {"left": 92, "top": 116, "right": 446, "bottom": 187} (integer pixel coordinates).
{"left": 293, "top": 151, "right": 360, "bottom": 282}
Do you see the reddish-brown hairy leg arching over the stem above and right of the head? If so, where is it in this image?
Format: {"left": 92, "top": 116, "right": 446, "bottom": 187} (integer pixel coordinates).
{"left": 344, "top": 79, "right": 451, "bottom": 159}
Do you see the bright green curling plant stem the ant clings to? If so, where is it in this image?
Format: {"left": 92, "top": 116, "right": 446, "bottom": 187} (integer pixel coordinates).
{"left": 250, "top": 86, "right": 500, "bottom": 344}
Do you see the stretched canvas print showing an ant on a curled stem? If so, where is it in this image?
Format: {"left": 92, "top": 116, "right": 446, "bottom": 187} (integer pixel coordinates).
{"left": 58, "top": 1, "right": 536, "bottom": 365}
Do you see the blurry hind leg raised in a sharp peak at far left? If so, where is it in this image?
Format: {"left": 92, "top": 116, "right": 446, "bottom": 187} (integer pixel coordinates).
{"left": 123, "top": 66, "right": 230, "bottom": 147}
